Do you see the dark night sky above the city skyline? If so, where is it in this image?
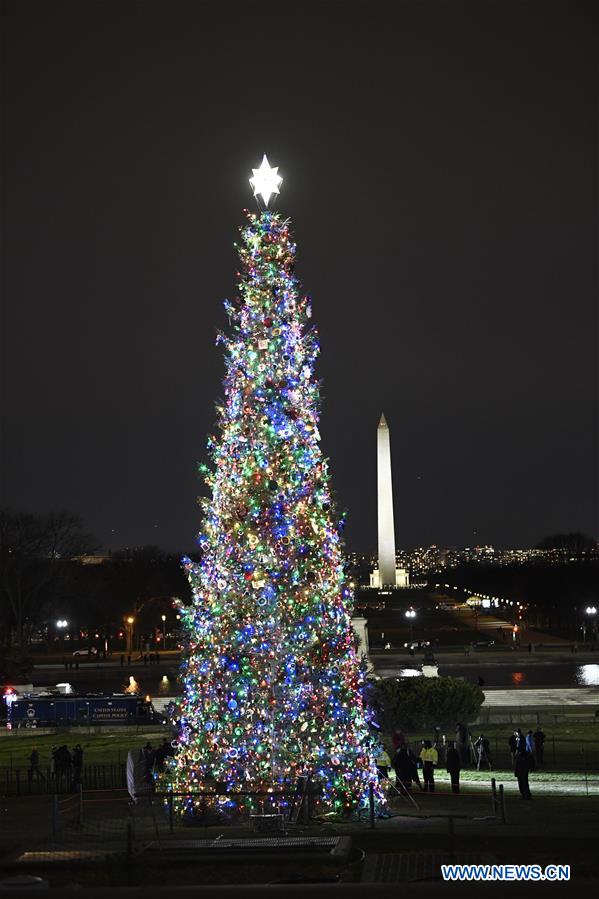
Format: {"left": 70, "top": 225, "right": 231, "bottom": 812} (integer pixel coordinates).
{"left": 1, "top": 0, "right": 599, "bottom": 550}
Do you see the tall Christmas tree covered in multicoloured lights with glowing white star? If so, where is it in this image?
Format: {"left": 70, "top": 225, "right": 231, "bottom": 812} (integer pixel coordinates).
{"left": 161, "top": 156, "right": 376, "bottom": 812}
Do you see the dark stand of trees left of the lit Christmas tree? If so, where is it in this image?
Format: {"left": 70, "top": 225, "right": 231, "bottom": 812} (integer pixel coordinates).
{"left": 0, "top": 509, "right": 189, "bottom": 672}
